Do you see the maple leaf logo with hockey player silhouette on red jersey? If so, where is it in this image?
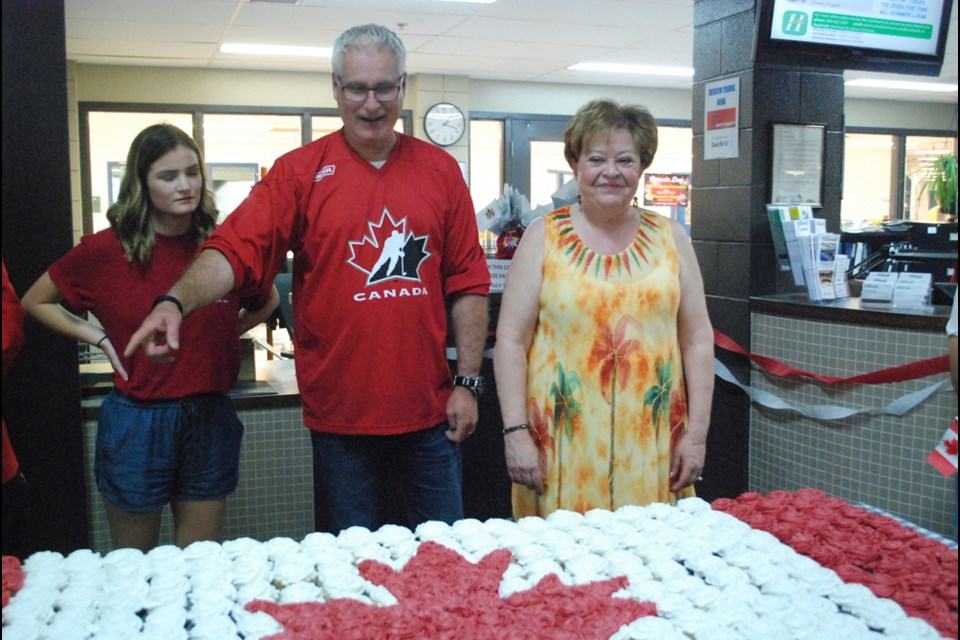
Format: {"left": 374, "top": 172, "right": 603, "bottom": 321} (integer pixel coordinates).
{"left": 347, "top": 208, "right": 431, "bottom": 286}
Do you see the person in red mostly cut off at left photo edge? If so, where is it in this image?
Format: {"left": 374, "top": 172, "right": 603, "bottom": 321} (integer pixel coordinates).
{"left": 0, "top": 261, "right": 27, "bottom": 558}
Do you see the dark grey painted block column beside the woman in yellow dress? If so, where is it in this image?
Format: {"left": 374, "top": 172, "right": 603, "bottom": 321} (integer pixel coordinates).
{"left": 691, "top": 0, "right": 843, "bottom": 500}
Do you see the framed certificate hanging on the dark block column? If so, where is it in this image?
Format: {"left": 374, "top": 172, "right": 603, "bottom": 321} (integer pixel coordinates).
{"left": 770, "top": 123, "right": 826, "bottom": 207}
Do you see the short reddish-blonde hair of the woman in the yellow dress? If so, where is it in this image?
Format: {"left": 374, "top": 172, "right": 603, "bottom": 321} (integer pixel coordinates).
{"left": 563, "top": 99, "right": 657, "bottom": 171}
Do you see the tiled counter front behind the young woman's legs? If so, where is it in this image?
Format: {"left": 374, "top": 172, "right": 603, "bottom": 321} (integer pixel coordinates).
{"left": 84, "top": 407, "right": 314, "bottom": 553}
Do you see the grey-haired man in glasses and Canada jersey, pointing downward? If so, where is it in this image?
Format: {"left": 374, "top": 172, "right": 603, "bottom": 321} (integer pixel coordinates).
{"left": 126, "top": 25, "right": 490, "bottom": 531}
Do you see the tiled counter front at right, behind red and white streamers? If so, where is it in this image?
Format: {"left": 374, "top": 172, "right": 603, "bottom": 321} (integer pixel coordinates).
{"left": 749, "top": 313, "right": 957, "bottom": 539}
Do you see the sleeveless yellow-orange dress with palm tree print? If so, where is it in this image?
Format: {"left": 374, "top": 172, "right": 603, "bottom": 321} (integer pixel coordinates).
{"left": 513, "top": 207, "right": 693, "bottom": 518}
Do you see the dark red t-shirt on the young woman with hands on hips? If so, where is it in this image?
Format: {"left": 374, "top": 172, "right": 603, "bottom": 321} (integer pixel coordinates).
{"left": 50, "top": 229, "right": 256, "bottom": 400}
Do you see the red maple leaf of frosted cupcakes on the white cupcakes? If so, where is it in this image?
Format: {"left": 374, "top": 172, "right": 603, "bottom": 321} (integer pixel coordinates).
{"left": 246, "top": 542, "right": 656, "bottom": 640}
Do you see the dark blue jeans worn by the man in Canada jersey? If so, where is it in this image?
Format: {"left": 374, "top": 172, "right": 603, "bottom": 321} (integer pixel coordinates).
{"left": 310, "top": 423, "right": 463, "bottom": 533}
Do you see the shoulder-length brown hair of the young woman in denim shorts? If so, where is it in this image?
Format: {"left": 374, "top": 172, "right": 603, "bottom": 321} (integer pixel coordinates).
{"left": 107, "top": 124, "right": 217, "bottom": 265}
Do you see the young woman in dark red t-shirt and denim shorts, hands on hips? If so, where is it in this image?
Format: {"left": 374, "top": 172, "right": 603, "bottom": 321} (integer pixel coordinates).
{"left": 23, "top": 124, "right": 279, "bottom": 551}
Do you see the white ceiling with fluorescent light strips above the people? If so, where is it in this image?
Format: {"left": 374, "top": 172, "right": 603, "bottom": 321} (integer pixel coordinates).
{"left": 65, "top": 0, "right": 957, "bottom": 103}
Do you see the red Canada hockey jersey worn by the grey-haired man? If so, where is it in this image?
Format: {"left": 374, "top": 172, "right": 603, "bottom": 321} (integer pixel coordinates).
{"left": 202, "top": 131, "right": 490, "bottom": 435}
